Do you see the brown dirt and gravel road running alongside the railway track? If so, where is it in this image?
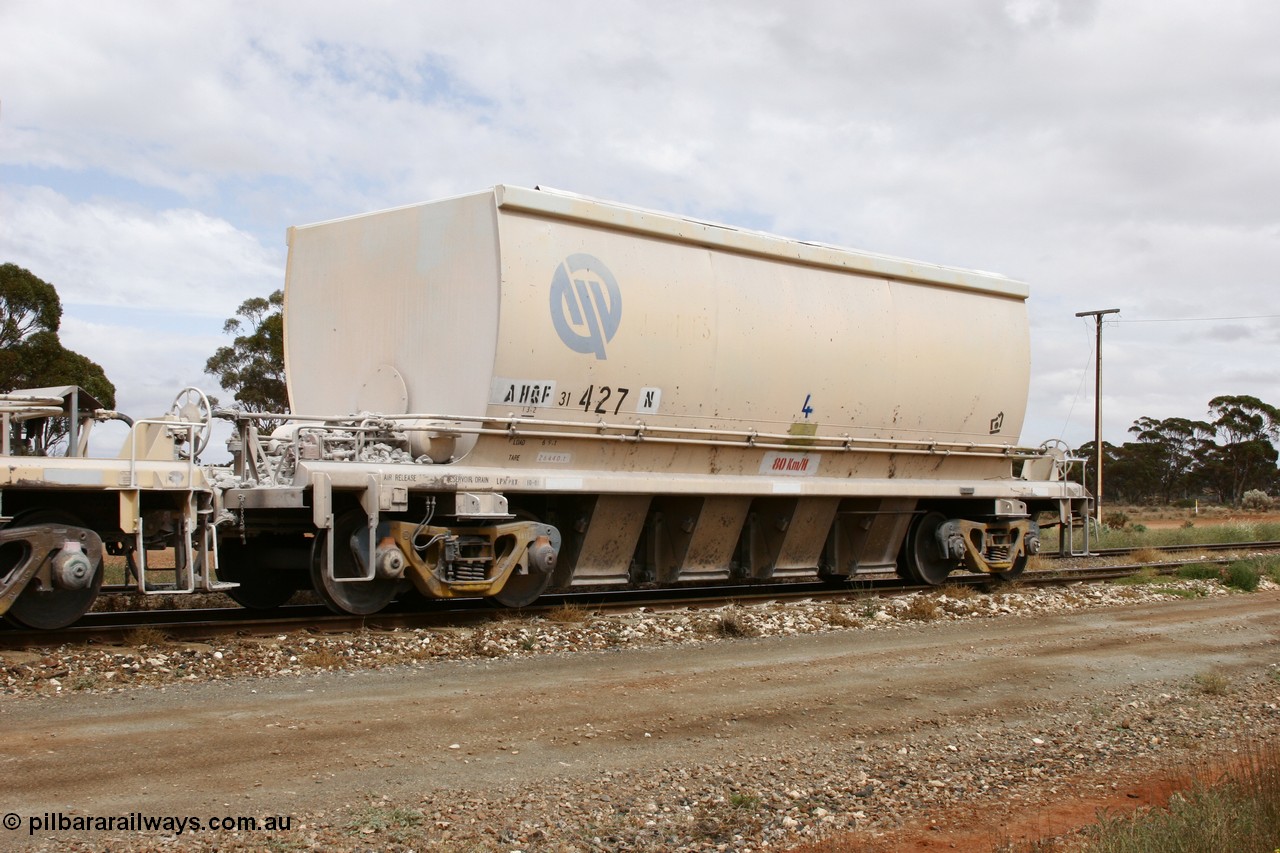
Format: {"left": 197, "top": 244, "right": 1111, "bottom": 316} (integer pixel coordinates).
{"left": 0, "top": 573, "right": 1280, "bottom": 850}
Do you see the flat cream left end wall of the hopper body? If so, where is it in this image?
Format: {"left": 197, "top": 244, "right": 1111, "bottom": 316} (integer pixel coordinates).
{"left": 284, "top": 192, "right": 499, "bottom": 461}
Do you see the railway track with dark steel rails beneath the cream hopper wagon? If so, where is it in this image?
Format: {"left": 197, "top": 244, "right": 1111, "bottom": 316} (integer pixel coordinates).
{"left": 0, "top": 542, "right": 1259, "bottom": 649}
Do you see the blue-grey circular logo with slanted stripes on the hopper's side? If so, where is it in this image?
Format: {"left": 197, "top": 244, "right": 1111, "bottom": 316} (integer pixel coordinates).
{"left": 550, "top": 254, "right": 622, "bottom": 360}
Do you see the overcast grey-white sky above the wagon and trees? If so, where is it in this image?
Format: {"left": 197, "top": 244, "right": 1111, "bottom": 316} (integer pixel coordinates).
{"left": 0, "top": 0, "right": 1280, "bottom": 455}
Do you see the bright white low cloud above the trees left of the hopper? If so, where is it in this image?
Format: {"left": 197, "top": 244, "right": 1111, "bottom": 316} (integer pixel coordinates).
{"left": 0, "top": 187, "right": 284, "bottom": 459}
